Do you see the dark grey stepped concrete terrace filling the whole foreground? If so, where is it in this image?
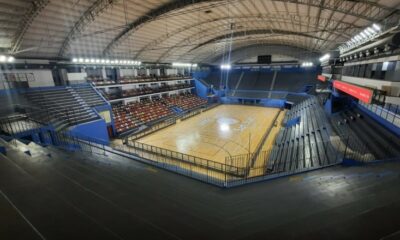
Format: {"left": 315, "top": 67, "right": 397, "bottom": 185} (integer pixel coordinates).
{"left": 0, "top": 140, "right": 400, "bottom": 240}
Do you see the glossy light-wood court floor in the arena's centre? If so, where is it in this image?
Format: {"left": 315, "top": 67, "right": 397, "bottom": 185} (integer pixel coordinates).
{"left": 137, "top": 105, "right": 279, "bottom": 163}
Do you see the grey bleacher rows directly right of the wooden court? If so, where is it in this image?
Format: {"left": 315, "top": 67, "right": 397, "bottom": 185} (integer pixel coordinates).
{"left": 268, "top": 97, "right": 338, "bottom": 172}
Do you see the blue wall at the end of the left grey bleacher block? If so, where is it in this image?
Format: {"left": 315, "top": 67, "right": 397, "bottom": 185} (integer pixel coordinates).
{"left": 69, "top": 119, "right": 110, "bottom": 145}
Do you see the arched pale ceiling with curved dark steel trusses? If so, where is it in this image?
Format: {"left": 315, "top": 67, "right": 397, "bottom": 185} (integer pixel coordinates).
{"left": 0, "top": 0, "right": 400, "bottom": 63}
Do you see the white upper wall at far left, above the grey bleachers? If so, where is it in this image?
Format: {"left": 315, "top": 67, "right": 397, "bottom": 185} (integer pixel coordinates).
{"left": 0, "top": 69, "right": 55, "bottom": 88}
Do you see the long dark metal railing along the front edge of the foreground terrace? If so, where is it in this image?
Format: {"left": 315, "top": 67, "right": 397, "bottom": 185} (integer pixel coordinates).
{"left": 0, "top": 112, "right": 400, "bottom": 187}
